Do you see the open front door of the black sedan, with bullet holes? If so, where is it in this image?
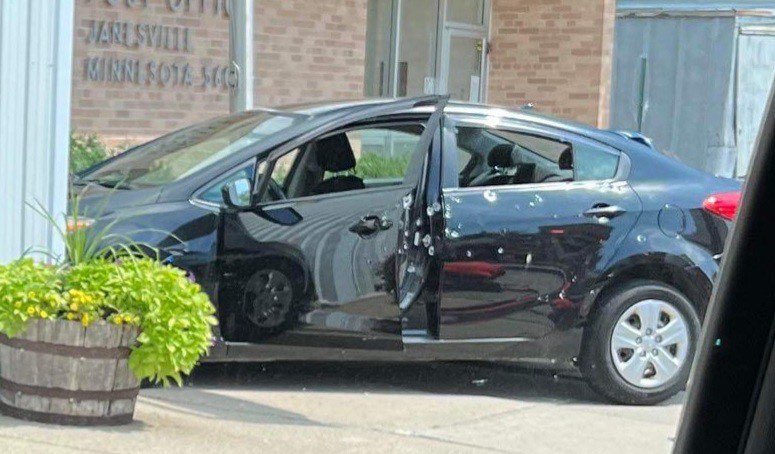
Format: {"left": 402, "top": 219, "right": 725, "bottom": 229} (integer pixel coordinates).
{"left": 218, "top": 96, "right": 447, "bottom": 357}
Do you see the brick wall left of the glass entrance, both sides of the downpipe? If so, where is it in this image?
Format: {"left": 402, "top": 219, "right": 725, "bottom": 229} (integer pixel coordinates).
{"left": 72, "top": 0, "right": 366, "bottom": 144}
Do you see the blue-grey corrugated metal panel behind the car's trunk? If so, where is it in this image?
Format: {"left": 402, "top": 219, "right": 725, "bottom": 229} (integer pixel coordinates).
{"left": 611, "top": 15, "right": 736, "bottom": 176}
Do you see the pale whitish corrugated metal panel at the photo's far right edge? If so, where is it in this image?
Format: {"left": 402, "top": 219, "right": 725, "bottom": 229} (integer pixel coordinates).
{"left": 736, "top": 25, "right": 775, "bottom": 176}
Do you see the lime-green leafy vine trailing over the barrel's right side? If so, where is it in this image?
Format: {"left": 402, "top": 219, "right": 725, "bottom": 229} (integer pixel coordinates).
{"left": 64, "top": 258, "right": 217, "bottom": 384}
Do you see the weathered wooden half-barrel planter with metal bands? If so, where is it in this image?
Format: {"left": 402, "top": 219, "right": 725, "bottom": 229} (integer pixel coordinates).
{"left": 0, "top": 320, "right": 140, "bottom": 426}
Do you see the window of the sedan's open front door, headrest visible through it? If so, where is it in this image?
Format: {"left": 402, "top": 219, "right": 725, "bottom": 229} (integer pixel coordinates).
{"left": 262, "top": 123, "right": 423, "bottom": 199}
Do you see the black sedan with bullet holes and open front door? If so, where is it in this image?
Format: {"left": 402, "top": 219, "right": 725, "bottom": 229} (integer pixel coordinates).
{"left": 73, "top": 97, "right": 741, "bottom": 404}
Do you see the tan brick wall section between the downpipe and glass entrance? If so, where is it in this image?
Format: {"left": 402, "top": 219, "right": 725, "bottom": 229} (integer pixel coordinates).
{"left": 255, "top": 0, "right": 366, "bottom": 106}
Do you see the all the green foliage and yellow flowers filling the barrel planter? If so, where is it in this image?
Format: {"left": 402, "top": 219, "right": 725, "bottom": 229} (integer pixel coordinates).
{"left": 0, "top": 192, "right": 217, "bottom": 385}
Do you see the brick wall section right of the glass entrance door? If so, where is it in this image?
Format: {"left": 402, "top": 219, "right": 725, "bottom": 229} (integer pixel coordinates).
{"left": 488, "top": 0, "right": 615, "bottom": 126}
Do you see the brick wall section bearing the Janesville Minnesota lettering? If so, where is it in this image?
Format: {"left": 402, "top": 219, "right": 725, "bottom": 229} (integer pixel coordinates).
{"left": 72, "top": 0, "right": 229, "bottom": 143}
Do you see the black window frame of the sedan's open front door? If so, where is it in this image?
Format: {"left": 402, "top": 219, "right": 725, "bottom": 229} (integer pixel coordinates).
{"left": 253, "top": 119, "right": 428, "bottom": 207}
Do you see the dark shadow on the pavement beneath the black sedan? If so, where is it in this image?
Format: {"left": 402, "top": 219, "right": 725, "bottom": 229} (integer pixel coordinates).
{"left": 177, "top": 362, "right": 683, "bottom": 405}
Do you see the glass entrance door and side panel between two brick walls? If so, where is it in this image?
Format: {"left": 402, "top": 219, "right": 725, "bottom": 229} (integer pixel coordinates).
{"left": 364, "top": 0, "right": 490, "bottom": 102}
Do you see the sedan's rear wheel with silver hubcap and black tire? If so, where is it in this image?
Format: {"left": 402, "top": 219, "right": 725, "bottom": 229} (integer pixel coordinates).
{"left": 580, "top": 280, "right": 701, "bottom": 405}
